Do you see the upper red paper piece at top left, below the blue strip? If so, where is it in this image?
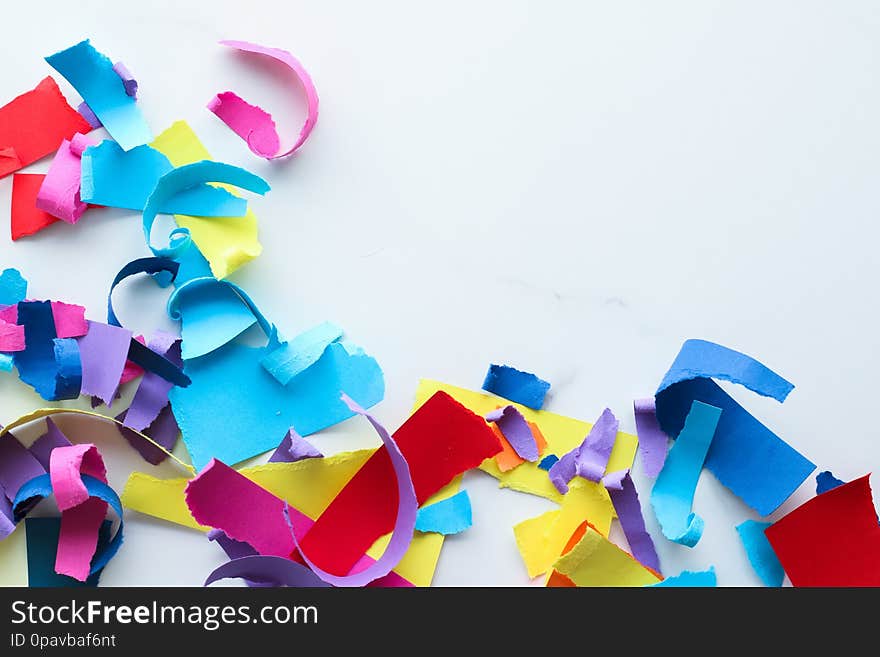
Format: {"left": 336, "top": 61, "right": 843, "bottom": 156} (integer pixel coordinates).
{"left": 0, "top": 77, "right": 92, "bottom": 178}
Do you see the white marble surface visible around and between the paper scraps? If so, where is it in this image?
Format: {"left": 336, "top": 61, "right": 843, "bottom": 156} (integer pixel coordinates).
{"left": 0, "top": 0, "right": 880, "bottom": 585}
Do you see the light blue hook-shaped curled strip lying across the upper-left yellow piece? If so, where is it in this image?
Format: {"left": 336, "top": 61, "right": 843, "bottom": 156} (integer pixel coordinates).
{"left": 143, "top": 160, "right": 271, "bottom": 258}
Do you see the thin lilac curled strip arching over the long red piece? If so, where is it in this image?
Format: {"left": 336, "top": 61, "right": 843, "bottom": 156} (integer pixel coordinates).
{"left": 284, "top": 393, "right": 419, "bottom": 586}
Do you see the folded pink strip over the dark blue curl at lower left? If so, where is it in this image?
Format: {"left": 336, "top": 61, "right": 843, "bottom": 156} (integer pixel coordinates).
{"left": 49, "top": 444, "right": 107, "bottom": 582}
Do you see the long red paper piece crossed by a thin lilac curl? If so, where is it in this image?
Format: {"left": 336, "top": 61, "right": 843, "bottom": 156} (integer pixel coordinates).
{"left": 300, "top": 391, "right": 501, "bottom": 575}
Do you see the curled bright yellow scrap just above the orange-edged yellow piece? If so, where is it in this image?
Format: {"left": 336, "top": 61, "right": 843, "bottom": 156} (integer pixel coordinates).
{"left": 513, "top": 478, "right": 614, "bottom": 577}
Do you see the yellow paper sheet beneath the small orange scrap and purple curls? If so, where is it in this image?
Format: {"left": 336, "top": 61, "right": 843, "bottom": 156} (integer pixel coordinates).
{"left": 416, "top": 379, "right": 639, "bottom": 502}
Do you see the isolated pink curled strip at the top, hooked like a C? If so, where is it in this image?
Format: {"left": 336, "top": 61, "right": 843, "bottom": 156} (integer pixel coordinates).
{"left": 208, "top": 41, "right": 318, "bottom": 160}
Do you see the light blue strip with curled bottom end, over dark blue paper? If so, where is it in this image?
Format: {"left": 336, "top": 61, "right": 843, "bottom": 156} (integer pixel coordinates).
{"left": 651, "top": 401, "right": 722, "bottom": 547}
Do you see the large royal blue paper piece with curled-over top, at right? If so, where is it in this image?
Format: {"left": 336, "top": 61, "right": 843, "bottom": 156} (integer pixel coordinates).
{"left": 656, "top": 340, "right": 816, "bottom": 516}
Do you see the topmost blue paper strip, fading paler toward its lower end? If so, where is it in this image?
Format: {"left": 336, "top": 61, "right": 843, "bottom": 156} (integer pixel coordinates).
{"left": 46, "top": 39, "right": 153, "bottom": 150}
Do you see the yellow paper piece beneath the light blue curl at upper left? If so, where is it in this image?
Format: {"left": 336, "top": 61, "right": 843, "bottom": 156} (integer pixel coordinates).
{"left": 150, "top": 121, "right": 263, "bottom": 278}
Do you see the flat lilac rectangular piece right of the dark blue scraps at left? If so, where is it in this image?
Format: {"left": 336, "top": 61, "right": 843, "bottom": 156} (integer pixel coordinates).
{"left": 76, "top": 321, "right": 132, "bottom": 406}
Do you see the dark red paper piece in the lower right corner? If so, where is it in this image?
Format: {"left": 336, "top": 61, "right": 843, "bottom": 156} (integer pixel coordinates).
{"left": 764, "top": 475, "right": 880, "bottom": 586}
